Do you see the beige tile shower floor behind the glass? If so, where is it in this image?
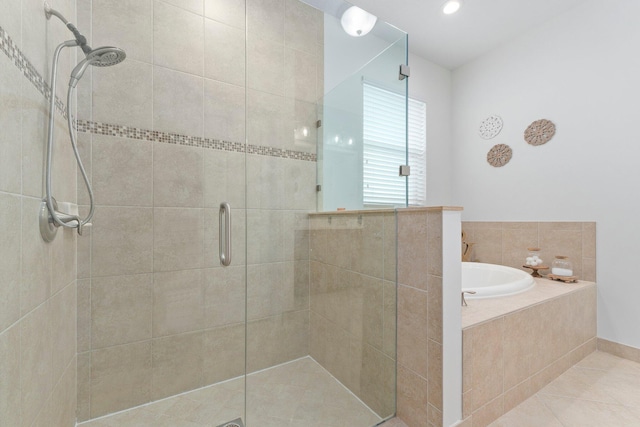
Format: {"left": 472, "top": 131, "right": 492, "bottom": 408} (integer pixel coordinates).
{"left": 79, "top": 357, "right": 382, "bottom": 427}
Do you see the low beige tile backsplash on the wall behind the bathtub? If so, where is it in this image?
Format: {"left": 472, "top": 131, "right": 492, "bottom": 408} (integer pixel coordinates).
{"left": 462, "top": 221, "right": 596, "bottom": 282}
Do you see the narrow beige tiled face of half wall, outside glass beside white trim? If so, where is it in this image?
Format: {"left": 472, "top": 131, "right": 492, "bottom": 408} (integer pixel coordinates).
{"left": 397, "top": 209, "right": 443, "bottom": 427}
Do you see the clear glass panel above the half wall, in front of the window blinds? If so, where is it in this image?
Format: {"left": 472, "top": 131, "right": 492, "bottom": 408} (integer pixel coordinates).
{"left": 318, "top": 12, "right": 407, "bottom": 212}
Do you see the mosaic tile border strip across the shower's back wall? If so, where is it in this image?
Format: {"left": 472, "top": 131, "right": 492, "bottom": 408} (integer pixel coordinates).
{"left": 75, "top": 120, "right": 317, "bottom": 162}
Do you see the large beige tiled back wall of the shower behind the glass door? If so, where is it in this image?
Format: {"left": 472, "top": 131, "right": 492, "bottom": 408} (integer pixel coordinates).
{"left": 78, "top": 0, "right": 323, "bottom": 420}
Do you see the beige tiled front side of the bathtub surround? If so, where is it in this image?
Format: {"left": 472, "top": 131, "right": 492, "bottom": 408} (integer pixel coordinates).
{"left": 462, "top": 285, "right": 596, "bottom": 427}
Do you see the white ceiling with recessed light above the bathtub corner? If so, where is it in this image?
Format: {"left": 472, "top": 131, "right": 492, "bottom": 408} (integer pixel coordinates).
{"left": 349, "top": 0, "right": 585, "bottom": 69}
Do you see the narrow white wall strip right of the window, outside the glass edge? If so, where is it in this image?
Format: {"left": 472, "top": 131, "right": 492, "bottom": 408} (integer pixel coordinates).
{"left": 409, "top": 52, "right": 452, "bottom": 206}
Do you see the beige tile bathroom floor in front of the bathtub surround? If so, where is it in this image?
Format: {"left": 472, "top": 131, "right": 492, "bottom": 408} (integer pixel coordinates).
{"left": 490, "top": 351, "right": 640, "bottom": 427}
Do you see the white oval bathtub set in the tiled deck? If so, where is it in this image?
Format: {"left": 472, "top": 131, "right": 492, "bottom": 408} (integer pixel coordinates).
{"left": 462, "top": 262, "right": 536, "bottom": 300}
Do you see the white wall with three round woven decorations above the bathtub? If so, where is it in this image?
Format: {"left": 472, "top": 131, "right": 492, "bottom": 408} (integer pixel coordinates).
{"left": 452, "top": 0, "right": 640, "bottom": 347}
